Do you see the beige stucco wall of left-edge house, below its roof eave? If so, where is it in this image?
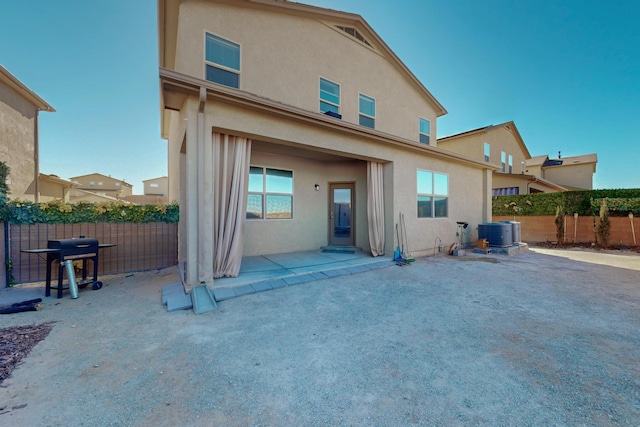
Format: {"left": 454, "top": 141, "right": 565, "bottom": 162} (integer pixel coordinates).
{"left": 0, "top": 77, "right": 37, "bottom": 201}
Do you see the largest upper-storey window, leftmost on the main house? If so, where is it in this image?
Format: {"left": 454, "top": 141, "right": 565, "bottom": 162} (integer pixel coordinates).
{"left": 205, "top": 33, "right": 240, "bottom": 89}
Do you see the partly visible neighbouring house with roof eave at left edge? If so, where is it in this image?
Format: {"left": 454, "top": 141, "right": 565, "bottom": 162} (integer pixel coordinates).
{"left": 0, "top": 65, "right": 55, "bottom": 202}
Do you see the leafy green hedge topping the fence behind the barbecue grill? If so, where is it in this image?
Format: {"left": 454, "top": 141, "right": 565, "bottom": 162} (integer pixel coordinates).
{"left": 0, "top": 200, "right": 180, "bottom": 225}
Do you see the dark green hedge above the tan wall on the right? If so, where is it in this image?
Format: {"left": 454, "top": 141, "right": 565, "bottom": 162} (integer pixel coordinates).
{"left": 493, "top": 188, "right": 640, "bottom": 216}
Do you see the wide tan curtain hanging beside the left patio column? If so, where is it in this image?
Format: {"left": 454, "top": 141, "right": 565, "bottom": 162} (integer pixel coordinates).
{"left": 213, "top": 132, "right": 251, "bottom": 278}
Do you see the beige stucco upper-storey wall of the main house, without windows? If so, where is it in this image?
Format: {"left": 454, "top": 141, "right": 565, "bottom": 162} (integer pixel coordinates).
{"left": 176, "top": 0, "right": 436, "bottom": 145}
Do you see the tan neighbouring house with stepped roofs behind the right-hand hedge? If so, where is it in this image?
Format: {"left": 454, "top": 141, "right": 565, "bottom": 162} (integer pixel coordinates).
{"left": 438, "top": 121, "right": 597, "bottom": 196}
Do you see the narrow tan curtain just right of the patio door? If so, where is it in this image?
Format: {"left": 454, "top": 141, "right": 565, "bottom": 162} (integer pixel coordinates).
{"left": 367, "top": 162, "right": 384, "bottom": 257}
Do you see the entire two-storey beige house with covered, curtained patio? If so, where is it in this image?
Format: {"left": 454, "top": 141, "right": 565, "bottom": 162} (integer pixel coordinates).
{"left": 158, "top": 0, "right": 496, "bottom": 291}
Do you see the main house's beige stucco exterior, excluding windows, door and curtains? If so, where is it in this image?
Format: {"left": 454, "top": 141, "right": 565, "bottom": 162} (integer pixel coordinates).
{"left": 158, "top": 0, "right": 495, "bottom": 285}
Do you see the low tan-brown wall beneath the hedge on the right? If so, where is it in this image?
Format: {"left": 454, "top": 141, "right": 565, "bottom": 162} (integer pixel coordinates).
{"left": 493, "top": 215, "right": 640, "bottom": 246}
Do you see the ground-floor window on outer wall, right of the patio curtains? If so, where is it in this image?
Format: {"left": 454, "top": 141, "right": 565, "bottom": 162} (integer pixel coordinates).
{"left": 417, "top": 169, "right": 449, "bottom": 218}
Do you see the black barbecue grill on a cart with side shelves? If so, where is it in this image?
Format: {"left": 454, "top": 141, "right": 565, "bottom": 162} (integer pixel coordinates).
{"left": 22, "top": 238, "right": 115, "bottom": 298}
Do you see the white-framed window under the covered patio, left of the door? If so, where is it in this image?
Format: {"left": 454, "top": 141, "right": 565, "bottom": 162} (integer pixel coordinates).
{"left": 247, "top": 166, "right": 293, "bottom": 219}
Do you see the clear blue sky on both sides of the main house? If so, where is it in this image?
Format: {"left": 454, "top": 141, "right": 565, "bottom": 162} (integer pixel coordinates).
{"left": 0, "top": 0, "right": 640, "bottom": 194}
